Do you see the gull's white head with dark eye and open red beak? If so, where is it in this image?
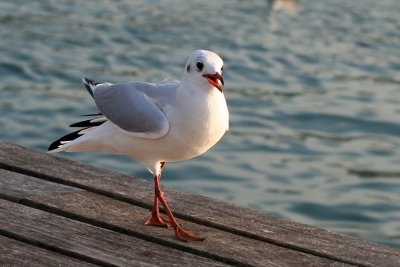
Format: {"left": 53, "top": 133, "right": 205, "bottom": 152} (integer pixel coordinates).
{"left": 182, "top": 50, "right": 224, "bottom": 93}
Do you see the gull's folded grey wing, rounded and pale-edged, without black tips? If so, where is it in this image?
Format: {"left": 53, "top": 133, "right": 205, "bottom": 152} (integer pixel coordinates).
{"left": 94, "top": 82, "right": 169, "bottom": 139}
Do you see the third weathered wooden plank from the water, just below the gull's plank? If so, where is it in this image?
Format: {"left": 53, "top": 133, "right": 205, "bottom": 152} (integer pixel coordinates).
{"left": 0, "top": 199, "right": 228, "bottom": 266}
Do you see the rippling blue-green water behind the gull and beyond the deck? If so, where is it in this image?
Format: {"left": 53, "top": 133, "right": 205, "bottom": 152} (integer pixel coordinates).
{"left": 0, "top": 0, "right": 400, "bottom": 247}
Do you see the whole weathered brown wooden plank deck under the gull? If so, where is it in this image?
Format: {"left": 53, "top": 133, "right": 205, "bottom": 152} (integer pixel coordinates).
{"left": 0, "top": 141, "right": 400, "bottom": 266}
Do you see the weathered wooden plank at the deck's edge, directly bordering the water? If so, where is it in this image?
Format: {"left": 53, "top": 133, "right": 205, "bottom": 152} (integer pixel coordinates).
{"left": 0, "top": 142, "right": 400, "bottom": 266}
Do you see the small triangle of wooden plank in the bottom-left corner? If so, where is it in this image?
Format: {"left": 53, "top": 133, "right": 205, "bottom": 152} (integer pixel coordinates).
{"left": 0, "top": 235, "right": 97, "bottom": 267}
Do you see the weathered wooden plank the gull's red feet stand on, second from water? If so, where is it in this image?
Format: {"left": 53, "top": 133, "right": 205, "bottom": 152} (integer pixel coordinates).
{"left": 0, "top": 169, "right": 345, "bottom": 266}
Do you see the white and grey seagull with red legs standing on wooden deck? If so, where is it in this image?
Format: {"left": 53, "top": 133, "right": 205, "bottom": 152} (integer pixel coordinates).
{"left": 48, "top": 50, "right": 229, "bottom": 241}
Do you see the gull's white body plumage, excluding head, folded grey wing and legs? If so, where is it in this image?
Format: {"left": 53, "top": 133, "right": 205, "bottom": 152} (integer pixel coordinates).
{"left": 57, "top": 78, "right": 229, "bottom": 174}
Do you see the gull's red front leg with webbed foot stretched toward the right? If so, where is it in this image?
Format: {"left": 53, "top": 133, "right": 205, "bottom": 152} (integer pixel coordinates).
{"left": 154, "top": 176, "right": 205, "bottom": 241}
